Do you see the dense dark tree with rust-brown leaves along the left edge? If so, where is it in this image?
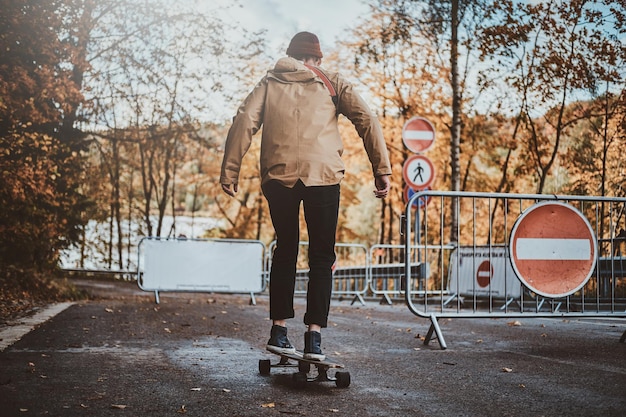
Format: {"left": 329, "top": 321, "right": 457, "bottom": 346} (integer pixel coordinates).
{"left": 0, "top": 0, "right": 86, "bottom": 271}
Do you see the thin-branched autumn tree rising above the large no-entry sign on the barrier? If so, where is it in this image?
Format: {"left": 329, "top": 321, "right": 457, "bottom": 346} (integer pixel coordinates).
{"left": 481, "top": 0, "right": 625, "bottom": 193}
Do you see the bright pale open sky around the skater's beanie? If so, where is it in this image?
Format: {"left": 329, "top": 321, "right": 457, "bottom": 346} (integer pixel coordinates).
{"left": 214, "top": 0, "right": 369, "bottom": 59}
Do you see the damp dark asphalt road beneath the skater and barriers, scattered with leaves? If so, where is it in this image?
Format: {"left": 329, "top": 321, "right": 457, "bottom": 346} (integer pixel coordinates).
{"left": 0, "top": 281, "right": 626, "bottom": 417}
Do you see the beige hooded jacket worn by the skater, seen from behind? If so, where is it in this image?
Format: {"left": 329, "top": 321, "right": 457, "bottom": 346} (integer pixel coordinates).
{"left": 220, "top": 57, "right": 391, "bottom": 187}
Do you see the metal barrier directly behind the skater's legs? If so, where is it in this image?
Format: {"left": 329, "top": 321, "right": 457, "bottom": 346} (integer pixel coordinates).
{"left": 266, "top": 241, "right": 369, "bottom": 305}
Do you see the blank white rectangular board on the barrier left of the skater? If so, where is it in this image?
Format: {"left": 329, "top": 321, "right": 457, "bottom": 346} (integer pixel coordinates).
{"left": 139, "top": 239, "right": 265, "bottom": 293}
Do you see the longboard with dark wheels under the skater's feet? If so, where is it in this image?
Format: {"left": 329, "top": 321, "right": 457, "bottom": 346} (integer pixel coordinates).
{"left": 259, "top": 350, "right": 350, "bottom": 388}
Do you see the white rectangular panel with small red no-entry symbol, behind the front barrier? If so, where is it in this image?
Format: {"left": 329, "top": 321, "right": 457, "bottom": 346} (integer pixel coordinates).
{"left": 448, "top": 246, "right": 521, "bottom": 298}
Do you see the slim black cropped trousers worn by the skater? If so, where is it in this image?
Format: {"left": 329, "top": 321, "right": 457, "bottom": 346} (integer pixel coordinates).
{"left": 263, "top": 181, "right": 339, "bottom": 327}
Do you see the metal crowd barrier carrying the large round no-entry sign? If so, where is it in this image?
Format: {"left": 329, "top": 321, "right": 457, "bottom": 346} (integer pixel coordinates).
{"left": 402, "top": 191, "right": 626, "bottom": 349}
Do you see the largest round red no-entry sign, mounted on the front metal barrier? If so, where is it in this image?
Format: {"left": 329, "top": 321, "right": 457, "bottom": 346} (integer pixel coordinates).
{"left": 509, "top": 202, "right": 598, "bottom": 298}
